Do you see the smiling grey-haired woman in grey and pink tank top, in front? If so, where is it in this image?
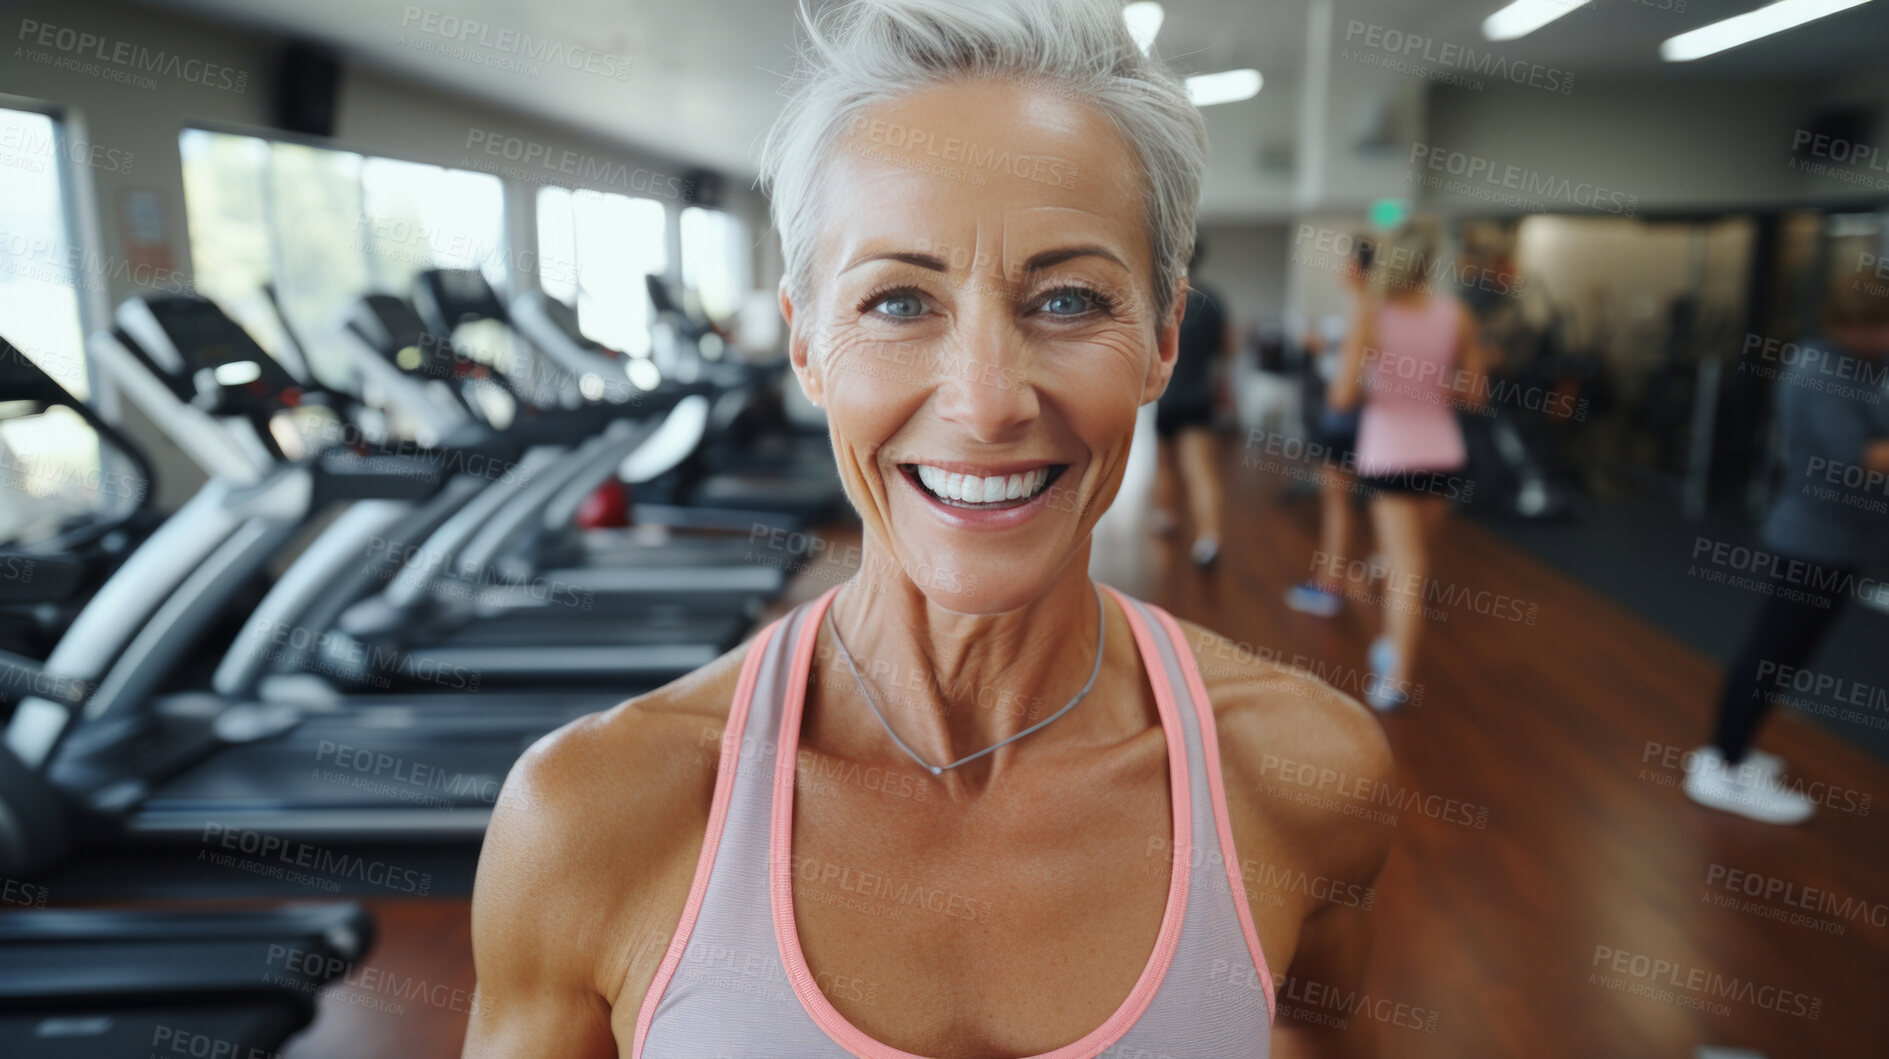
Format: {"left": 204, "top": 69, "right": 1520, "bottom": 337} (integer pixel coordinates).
{"left": 467, "top": 0, "right": 1390, "bottom": 1059}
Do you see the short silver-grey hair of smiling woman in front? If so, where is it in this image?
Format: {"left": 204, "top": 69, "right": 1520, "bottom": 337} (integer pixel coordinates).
{"left": 761, "top": 0, "right": 1207, "bottom": 317}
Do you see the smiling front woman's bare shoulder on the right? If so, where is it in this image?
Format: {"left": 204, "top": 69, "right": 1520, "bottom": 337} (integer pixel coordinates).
{"left": 1181, "top": 621, "right": 1396, "bottom": 878}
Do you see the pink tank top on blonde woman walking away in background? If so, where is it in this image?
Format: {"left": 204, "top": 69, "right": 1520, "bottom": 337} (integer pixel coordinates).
{"left": 1358, "top": 294, "right": 1477, "bottom": 476}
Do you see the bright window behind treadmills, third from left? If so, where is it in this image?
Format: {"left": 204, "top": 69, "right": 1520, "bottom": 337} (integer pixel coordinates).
{"left": 538, "top": 187, "right": 669, "bottom": 357}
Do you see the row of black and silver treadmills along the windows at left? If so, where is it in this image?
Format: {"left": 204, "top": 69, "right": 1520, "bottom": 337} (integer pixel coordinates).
{"left": 0, "top": 270, "right": 841, "bottom": 1057}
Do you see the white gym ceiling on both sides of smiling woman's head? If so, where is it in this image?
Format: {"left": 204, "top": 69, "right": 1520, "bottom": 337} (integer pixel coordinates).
{"left": 144, "top": 0, "right": 1889, "bottom": 176}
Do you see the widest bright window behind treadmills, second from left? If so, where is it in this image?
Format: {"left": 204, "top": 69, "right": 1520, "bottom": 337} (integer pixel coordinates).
{"left": 179, "top": 128, "right": 508, "bottom": 379}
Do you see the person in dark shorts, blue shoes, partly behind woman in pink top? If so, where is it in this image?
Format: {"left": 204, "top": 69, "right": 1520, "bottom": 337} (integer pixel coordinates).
{"left": 1286, "top": 238, "right": 1371, "bottom": 617}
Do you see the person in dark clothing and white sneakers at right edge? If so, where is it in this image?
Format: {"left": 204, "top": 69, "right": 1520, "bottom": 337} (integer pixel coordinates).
{"left": 1685, "top": 268, "right": 1889, "bottom": 823}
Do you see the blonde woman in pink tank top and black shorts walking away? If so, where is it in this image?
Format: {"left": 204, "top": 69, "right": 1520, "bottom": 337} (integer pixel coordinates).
{"left": 1330, "top": 221, "right": 1487, "bottom": 710}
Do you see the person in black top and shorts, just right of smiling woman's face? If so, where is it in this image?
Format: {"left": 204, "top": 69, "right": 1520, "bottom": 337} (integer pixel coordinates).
{"left": 1154, "top": 234, "right": 1234, "bottom": 568}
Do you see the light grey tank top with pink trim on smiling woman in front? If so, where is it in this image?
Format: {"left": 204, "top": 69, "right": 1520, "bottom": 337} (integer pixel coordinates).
{"left": 631, "top": 589, "right": 1273, "bottom": 1059}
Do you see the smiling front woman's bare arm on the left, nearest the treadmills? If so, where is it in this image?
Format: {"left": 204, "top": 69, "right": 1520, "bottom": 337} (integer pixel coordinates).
{"left": 465, "top": 698, "right": 721, "bottom": 1059}
